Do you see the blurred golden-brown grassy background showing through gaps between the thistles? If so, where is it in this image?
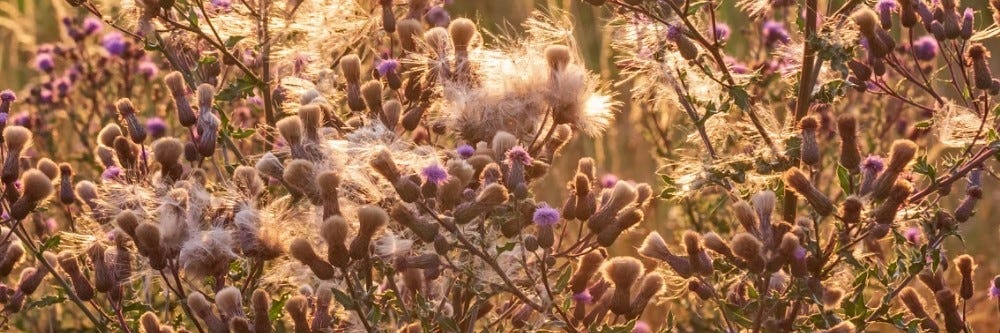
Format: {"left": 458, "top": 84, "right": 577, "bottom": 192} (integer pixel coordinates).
{"left": 0, "top": 0, "right": 1000, "bottom": 332}
